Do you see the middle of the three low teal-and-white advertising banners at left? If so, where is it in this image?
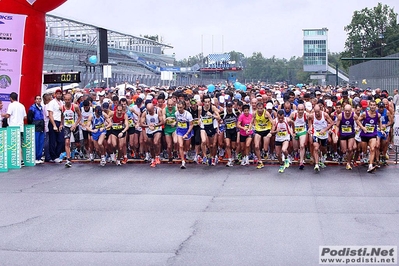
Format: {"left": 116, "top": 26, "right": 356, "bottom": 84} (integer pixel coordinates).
{"left": 6, "top": 127, "right": 21, "bottom": 169}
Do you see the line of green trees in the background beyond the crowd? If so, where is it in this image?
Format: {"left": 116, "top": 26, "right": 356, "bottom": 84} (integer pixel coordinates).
{"left": 175, "top": 3, "right": 399, "bottom": 84}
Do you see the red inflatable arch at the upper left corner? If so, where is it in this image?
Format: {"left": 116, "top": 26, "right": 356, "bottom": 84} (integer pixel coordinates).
{"left": 0, "top": 0, "right": 67, "bottom": 108}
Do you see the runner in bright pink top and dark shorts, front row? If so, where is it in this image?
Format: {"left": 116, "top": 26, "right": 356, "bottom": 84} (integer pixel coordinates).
{"left": 237, "top": 105, "right": 253, "bottom": 165}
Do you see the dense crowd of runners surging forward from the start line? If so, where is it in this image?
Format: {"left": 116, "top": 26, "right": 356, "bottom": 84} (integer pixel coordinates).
{"left": 13, "top": 84, "right": 399, "bottom": 173}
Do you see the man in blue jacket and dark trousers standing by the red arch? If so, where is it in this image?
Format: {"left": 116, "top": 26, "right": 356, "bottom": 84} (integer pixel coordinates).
{"left": 28, "top": 95, "right": 45, "bottom": 164}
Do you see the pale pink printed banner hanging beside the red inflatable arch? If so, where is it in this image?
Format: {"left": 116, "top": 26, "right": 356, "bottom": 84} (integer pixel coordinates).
{"left": 0, "top": 12, "right": 26, "bottom": 112}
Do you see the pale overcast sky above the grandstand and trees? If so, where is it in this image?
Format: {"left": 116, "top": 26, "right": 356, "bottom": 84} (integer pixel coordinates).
{"left": 50, "top": 0, "right": 399, "bottom": 60}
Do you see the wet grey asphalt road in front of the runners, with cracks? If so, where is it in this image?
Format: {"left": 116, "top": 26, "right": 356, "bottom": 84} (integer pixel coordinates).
{"left": 0, "top": 164, "right": 399, "bottom": 266}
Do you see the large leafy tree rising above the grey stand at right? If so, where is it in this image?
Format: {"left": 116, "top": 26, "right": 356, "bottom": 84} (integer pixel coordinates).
{"left": 342, "top": 3, "right": 399, "bottom": 67}
